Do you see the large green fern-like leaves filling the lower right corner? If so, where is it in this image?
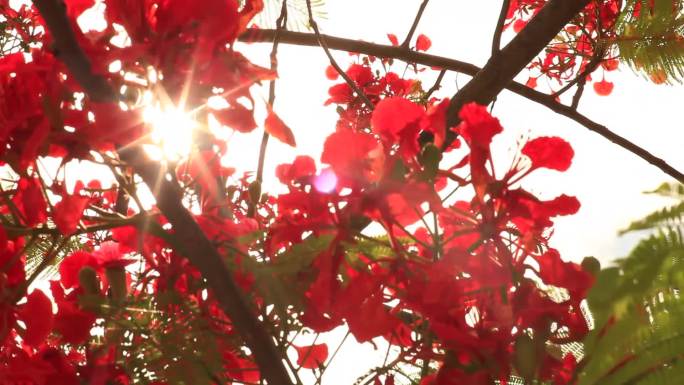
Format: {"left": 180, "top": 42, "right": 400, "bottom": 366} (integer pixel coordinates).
{"left": 578, "top": 185, "right": 684, "bottom": 385}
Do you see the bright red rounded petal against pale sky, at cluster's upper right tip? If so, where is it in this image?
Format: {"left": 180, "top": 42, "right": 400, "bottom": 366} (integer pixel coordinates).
{"left": 522, "top": 136, "right": 575, "bottom": 171}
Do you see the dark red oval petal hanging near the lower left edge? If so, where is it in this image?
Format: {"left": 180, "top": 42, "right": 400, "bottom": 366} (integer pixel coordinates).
{"left": 19, "top": 289, "right": 55, "bottom": 347}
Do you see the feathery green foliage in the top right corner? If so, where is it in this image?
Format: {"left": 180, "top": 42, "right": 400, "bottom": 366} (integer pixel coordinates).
{"left": 616, "top": 0, "right": 684, "bottom": 83}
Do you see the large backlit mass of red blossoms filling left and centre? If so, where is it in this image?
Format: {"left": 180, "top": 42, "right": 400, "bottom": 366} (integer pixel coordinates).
{"left": 0, "top": 0, "right": 593, "bottom": 385}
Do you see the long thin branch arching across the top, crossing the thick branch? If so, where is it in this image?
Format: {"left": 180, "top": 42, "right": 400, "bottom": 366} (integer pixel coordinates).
{"left": 240, "top": 30, "right": 684, "bottom": 183}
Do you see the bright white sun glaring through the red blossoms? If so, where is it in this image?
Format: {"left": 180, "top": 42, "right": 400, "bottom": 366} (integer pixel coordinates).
{"left": 143, "top": 106, "right": 198, "bottom": 160}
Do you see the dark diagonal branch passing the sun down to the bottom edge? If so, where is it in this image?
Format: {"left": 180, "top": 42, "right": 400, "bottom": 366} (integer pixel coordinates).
{"left": 34, "top": 0, "right": 292, "bottom": 385}
